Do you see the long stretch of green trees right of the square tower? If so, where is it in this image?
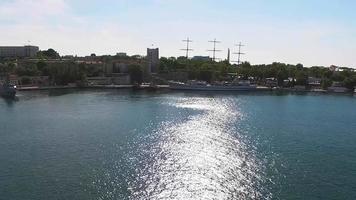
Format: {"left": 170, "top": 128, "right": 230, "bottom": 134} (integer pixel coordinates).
{"left": 159, "top": 57, "right": 356, "bottom": 89}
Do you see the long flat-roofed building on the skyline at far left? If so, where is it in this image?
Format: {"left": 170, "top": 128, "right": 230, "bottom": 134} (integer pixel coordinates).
{"left": 0, "top": 46, "right": 39, "bottom": 58}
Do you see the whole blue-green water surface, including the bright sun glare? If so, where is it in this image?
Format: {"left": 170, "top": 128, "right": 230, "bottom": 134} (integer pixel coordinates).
{"left": 0, "top": 90, "right": 356, "bottom": 200}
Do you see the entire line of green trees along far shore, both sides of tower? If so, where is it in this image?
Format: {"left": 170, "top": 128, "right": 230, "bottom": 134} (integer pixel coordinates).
{"left": 0, "top": 49, "right": 356, "bottom": 89}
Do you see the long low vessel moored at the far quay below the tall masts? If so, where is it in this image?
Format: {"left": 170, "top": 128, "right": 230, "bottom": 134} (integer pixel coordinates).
{"left": 169, "top": 81, "right": 257, "bottom": 91}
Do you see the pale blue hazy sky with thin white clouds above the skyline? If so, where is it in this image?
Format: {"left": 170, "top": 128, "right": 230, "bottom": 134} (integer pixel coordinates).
{"left": 0, "top": 0, "right": 356, "bottom": 68}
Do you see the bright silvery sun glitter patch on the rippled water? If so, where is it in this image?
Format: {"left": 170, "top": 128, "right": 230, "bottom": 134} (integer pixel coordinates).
{"left": 131, "top": 98, "right": 270, "bottom": 199}
